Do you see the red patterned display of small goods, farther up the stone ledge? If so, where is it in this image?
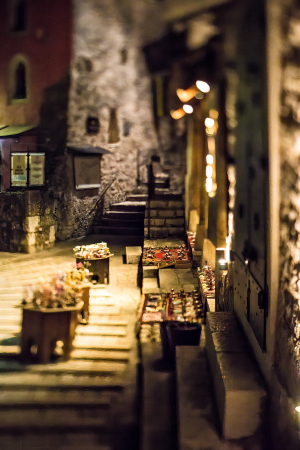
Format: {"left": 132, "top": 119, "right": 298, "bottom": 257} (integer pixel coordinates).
{"left": 143, "top": 245, "right": 189, "bottom": 267}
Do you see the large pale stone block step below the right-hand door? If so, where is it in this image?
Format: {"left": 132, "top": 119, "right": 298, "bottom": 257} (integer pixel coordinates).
{"left": 206, "top": 312, "right": 267, "bottom": 439}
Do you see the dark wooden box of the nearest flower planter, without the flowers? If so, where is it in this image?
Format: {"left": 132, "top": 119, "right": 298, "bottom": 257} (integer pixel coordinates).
{"left": 21, "top": 301, "right": 84, "bottom": 364}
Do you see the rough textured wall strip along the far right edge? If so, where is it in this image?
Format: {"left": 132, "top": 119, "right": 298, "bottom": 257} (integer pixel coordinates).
{"left": 275, "top": 2, "right": 300, "bottom": 403}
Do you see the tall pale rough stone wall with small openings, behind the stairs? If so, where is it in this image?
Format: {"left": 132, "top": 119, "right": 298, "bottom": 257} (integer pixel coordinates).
{"left": 68, "top": 0, "right": 162, "bottom": 210}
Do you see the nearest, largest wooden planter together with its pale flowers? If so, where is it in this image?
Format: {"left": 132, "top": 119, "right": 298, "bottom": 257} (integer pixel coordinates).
{"left": 21, "top": 272, "right": 84, "bottom": 363}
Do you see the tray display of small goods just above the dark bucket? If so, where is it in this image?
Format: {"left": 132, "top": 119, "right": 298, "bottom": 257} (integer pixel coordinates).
{"left": 141, "top": 289, "right": 204, "bottom": 323}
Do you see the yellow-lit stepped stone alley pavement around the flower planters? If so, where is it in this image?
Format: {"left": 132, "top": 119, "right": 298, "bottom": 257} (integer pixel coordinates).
{"left": 0, "top": 236, "right": 139, "bottom": 450}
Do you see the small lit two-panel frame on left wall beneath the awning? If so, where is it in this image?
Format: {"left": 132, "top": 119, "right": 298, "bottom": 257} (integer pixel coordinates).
{"left": 11, "top": 152, "right": 45, "bottom": 187}
